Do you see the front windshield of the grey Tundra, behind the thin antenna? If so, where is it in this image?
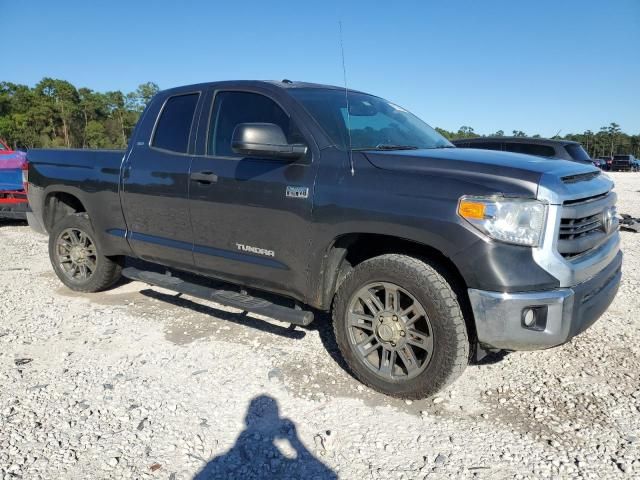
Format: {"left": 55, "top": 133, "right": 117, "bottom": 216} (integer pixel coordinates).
{"left": 289, "top": 88, "right": 453, "bottom": 150}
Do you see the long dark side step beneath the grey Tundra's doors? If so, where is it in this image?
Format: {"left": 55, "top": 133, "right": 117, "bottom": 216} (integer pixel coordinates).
{"left": 122, "top": 267, "right": 313, "bottom": 327}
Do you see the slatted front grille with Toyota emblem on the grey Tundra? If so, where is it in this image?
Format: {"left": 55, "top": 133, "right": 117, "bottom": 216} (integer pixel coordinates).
{"left": 558, "top": 192, "right": 618, "bottom": 260}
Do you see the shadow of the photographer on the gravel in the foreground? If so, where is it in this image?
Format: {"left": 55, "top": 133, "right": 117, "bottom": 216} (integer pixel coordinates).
{"left": 194, "top": 395, "right": 338, "bottom": 480}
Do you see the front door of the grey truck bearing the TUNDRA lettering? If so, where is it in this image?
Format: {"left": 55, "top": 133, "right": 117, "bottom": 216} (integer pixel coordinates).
{"left": 190, "top": 88, "right": 318, "bottom": 297}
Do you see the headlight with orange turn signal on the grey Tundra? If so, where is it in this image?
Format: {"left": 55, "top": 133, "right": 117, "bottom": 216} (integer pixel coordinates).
{"left": 458, "top": 196, "right": 547, "bottom": 247}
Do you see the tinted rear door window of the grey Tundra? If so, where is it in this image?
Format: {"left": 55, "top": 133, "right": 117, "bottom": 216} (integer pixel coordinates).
{"left": 151, "top": 93, "right": 199, "bottom": 153}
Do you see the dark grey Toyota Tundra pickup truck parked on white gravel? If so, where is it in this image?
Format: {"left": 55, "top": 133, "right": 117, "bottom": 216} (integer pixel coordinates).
{"left": 27, "top": 80, "right": 622, "bottom": 398}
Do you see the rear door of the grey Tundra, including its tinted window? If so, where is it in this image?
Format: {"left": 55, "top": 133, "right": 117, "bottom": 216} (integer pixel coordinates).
{"left": 122, "top": 91, "right": 201, "bottom": 268}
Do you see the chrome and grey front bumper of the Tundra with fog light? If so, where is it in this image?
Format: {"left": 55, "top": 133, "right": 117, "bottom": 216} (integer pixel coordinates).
{"left": 469, "top": 252, "right": 622, "bottom": 350}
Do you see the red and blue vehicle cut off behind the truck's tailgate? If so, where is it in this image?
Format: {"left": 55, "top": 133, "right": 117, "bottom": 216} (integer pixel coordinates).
{"left": 0, "top": 140, "right": 29, "bottom": 220}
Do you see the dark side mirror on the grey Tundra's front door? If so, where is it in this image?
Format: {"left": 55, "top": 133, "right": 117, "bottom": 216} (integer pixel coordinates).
{"left": 231, "top": 123, "right": 308, "bottom": 160}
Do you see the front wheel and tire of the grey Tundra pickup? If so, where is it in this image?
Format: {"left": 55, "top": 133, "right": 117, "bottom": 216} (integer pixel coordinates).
{"left": 333, "top": 254, "right": 470, "bottom": 399}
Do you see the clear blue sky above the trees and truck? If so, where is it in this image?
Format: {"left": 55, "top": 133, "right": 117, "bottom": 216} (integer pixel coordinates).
{"left": 5, "top": 0, "right": 640, "bottom": 136}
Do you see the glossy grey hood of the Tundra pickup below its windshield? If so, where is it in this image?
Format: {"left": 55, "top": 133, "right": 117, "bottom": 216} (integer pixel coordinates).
{"left": 364, "top": 148, "right": 600, "bottom": 196}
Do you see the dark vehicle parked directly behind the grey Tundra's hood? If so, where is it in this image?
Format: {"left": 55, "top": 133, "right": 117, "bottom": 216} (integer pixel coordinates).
{"left": 451, "top": 137, "right": 592, "bottom": 164}
